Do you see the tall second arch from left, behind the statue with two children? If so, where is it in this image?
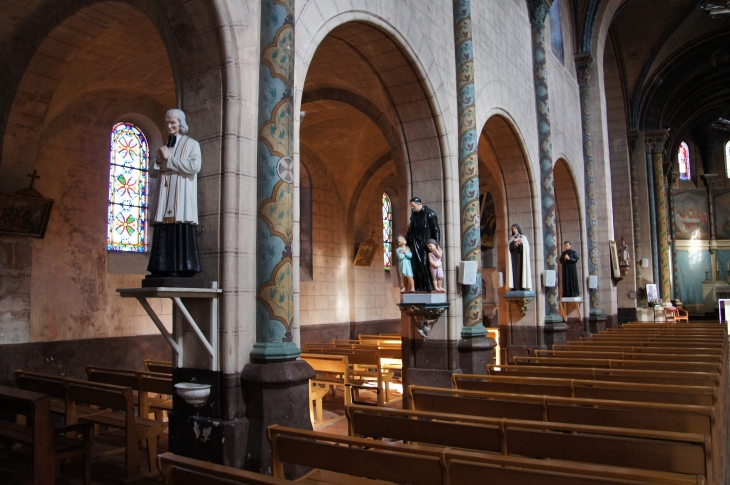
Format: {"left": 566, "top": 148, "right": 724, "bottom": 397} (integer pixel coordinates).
{"left": 295, "top": 18, "right": 446, "bottom": 337}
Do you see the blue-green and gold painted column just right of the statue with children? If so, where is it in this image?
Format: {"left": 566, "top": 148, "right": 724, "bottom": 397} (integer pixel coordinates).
{"left": 454, "top": 0, "right": 480, "bottom": 337}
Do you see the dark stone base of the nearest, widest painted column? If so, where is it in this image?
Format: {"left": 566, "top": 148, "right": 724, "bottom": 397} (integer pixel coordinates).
{"left": 241, "top": 360, "right": 315, "bottom": 480}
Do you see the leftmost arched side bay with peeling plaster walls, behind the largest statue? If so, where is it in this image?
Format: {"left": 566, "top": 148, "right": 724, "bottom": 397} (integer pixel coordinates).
{"left": 0, "top": 0, "right": 224, "bottom": 341}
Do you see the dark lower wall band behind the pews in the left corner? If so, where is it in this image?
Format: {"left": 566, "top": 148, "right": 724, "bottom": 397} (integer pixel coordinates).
{"left": 0, "top": 334, "right": 172, "bottom": 386}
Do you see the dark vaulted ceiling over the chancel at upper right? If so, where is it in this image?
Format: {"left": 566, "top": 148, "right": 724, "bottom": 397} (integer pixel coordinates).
{"left": 573, "top": 0, "right": 730, "bottom": 169}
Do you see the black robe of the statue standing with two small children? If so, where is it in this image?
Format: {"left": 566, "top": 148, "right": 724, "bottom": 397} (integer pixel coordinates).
{"left": 406, "top": 205, "right": 441, "bottom": 291}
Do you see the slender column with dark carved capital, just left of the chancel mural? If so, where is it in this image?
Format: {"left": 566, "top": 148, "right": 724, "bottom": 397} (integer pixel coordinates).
{"left": 644, "top": 131, "right": 672, "bottom": 301}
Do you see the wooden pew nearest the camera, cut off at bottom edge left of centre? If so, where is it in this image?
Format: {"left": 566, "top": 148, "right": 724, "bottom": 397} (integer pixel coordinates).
{"left": 157, "top": 453, "right": 302, "bottom": 485}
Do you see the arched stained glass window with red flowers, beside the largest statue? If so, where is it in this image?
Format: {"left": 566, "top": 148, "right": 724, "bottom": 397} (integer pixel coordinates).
{"left": 106, "top": 123, "right": 149, "bottom": 253}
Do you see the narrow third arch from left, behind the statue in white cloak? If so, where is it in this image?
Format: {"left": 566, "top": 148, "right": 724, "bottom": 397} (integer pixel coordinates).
{"left": 479, "top": 113, "right": 544, "bottom": 326}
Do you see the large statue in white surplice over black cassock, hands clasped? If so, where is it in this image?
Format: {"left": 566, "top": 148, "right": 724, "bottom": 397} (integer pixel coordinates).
{"left": 143, "top": 109, "right": 202, "bottom": 286}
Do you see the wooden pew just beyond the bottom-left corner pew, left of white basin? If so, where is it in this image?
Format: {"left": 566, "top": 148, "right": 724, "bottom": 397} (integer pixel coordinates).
{"left": 66, "top": 381, "right": 167, "bottom": 479}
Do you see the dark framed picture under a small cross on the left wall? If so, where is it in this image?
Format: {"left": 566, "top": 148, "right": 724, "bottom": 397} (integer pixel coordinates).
{"left": 0, "top": 194, "right": 53, "bottom": 239}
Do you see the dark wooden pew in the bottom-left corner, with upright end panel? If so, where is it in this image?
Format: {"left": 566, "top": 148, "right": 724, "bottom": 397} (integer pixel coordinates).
{"left": 0, "top": 386, "right": 91, "bottom": 485}
